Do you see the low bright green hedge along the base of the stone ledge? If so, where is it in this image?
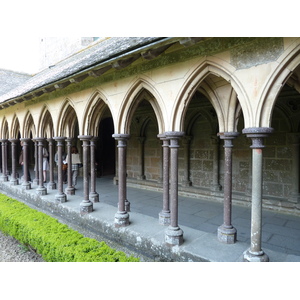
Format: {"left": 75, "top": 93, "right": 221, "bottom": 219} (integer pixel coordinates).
{"left": 0, "top": 194, "right": 139, "bottom": 262}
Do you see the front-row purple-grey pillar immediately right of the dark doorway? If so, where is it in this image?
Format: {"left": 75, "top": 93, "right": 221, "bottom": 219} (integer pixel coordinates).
{"left": 112, "top": 134, "right": 130, "bottom": 227}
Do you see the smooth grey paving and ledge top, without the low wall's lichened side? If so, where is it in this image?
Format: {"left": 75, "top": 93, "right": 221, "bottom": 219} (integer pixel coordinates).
{"left": 2, "top": 173, "right": 300, "bottom": 261}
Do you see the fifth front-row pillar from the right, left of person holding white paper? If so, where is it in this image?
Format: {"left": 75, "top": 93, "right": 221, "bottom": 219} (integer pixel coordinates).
{"left": 53, "top": 137, "right": 67, "bottom": 203}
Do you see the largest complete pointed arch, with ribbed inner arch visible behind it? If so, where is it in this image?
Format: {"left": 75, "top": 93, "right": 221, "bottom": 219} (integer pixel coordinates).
{"left": 172, "top": 60, "right": 251, "bottom": 132}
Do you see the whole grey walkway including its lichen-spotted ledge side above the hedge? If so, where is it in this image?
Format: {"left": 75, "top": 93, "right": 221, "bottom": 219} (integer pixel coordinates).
{"left": 0, "top": 172, "right": 300, "bottom": 262}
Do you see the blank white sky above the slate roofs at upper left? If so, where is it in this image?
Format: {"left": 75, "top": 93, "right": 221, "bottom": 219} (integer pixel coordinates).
{"left": 0, "top": 36, "right": 39, "bottom": 74}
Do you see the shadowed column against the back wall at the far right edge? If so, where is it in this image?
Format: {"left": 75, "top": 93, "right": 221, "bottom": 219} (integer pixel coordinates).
{"left": 288, "top": 133, "right": 300, "bottom": 203}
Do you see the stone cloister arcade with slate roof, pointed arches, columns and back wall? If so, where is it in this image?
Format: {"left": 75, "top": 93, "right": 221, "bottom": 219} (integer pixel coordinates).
{"left": 0, "top": 37, "right": 300, "bottom": 261}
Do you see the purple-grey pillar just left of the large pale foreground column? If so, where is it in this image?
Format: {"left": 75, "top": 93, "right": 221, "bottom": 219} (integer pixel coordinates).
{"left": 218, "top": 132, "right": 239, "bottom": 244}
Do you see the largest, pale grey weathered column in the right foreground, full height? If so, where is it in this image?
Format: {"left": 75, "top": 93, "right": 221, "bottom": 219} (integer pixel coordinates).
{"left": 243, "top": 127, "right": 273, "bottom": 262}
